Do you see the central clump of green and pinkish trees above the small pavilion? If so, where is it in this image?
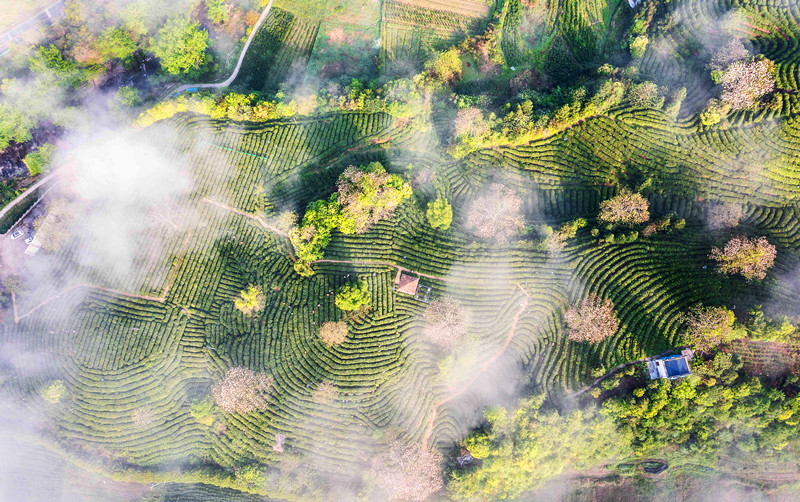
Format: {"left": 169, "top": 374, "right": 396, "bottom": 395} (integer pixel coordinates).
{"left": 289, "top": 162, "right": 411, "bottom": 275}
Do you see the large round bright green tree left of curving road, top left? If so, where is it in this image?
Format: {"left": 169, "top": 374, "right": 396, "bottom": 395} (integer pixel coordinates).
{"left": 151, "top": 18, "right": 209, "bottom": 76}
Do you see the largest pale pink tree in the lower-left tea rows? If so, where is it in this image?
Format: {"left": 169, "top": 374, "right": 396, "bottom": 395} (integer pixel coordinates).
{"left": 211, "top": 368, "right": 272, "bottom": 413}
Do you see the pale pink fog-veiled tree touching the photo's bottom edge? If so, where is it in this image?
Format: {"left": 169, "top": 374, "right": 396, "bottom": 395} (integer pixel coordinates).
{"left": 371, "top": 441, "right": 444, "bottom": 500}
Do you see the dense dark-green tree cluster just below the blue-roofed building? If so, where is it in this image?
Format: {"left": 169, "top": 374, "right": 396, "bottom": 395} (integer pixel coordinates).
{"left": 603, "top": 352, "right": 800, "bottom": 461}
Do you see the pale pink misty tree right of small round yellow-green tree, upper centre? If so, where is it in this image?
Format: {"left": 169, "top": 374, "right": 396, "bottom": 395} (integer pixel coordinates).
{"left": 467, "top": 183, "right": 523, "bottom": 241}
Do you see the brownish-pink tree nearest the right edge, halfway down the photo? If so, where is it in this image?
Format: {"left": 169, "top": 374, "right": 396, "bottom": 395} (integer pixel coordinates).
{"left": 711, "top": 235, "right": 777, "bottom": 281}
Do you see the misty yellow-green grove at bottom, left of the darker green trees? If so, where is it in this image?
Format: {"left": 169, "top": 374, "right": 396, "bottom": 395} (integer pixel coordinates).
{"left": 448, "top": 395, "right": 629, "bottom": 500}
